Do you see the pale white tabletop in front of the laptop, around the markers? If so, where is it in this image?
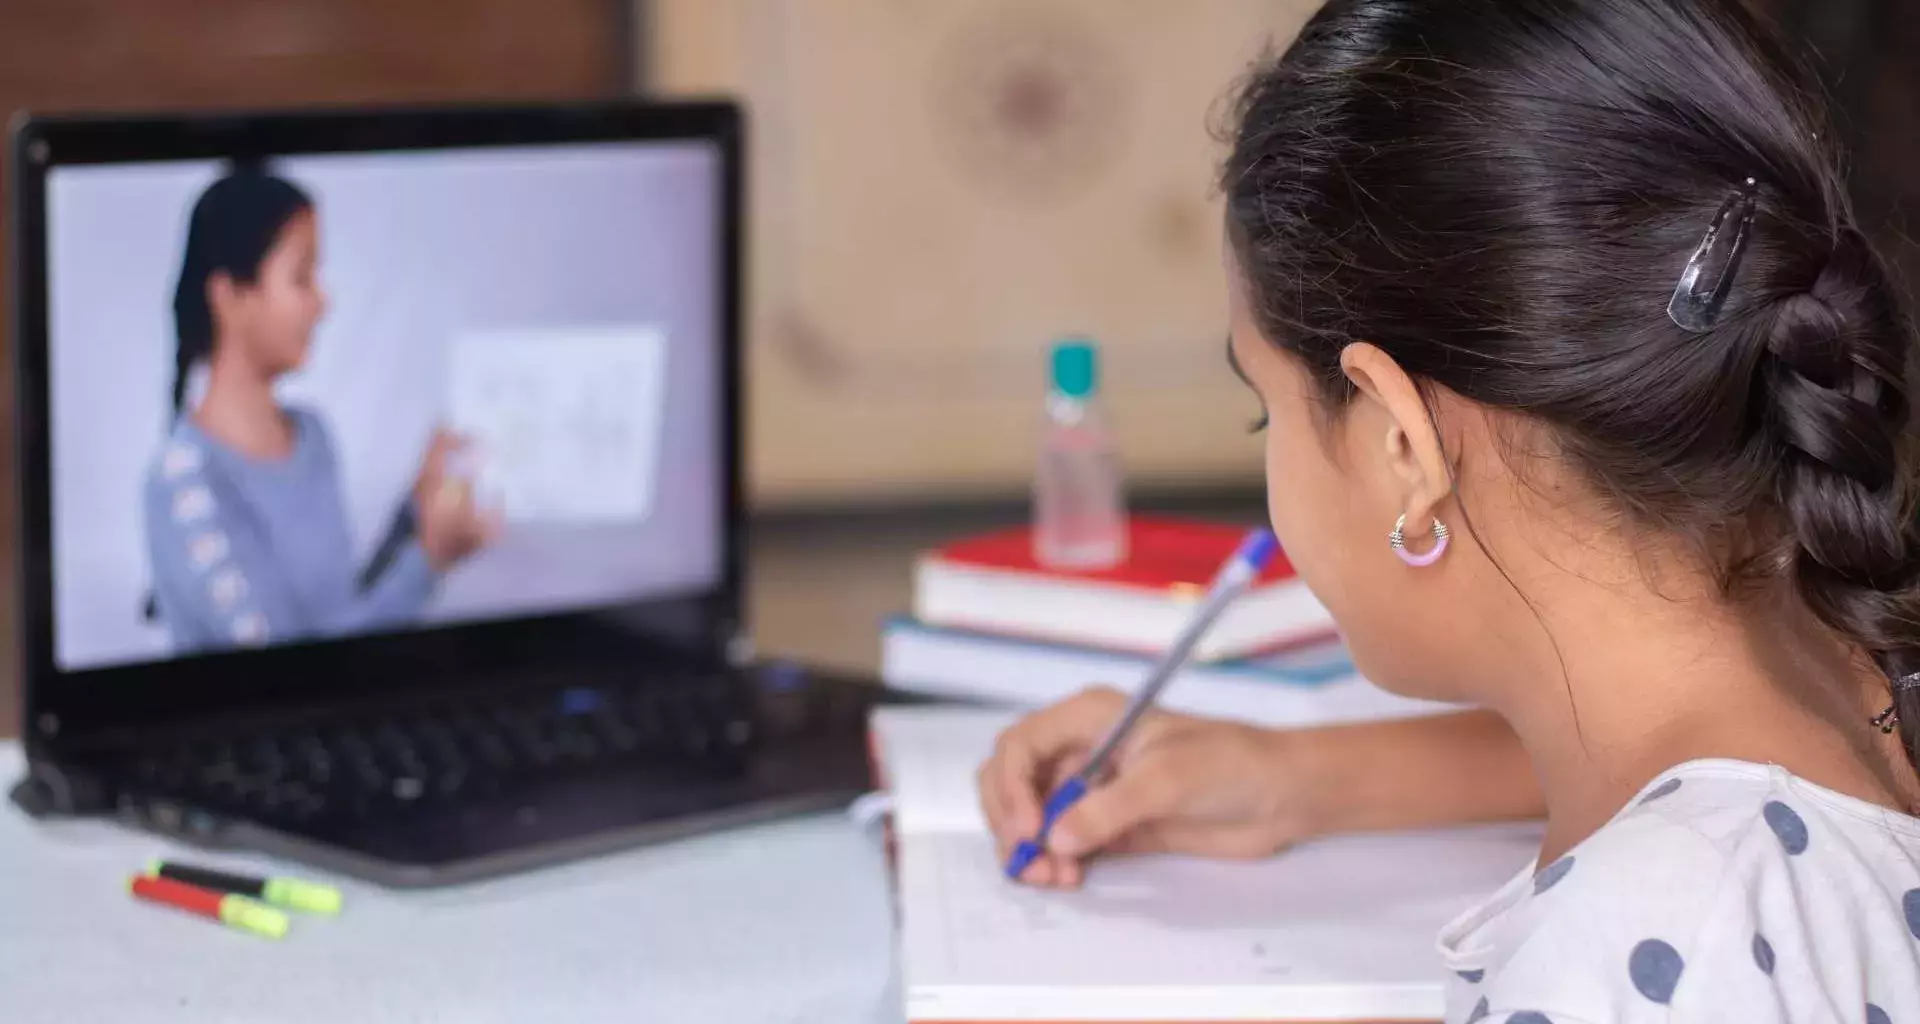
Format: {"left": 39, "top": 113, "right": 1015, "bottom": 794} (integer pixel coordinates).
{"left": 0, "top": 742, "right": 902, "bottom": 1024}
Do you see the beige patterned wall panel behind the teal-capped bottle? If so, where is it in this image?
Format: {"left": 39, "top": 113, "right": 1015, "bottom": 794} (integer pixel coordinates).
{"left": 641, "top": 0, "right": 1317, "bottom": 505}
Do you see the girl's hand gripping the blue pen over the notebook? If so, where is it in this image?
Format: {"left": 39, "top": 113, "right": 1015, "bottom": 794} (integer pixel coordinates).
{"left": 979, "top": 690, "right": 1311, "bottom": 888}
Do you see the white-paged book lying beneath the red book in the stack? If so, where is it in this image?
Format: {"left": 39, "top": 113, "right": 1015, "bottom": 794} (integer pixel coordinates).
{"left": 879, "top": 619, "right": 1457, "bottom": 726}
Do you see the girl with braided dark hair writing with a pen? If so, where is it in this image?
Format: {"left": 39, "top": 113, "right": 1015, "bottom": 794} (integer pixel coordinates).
{"left": 981, "top": 0, "right": 1920, "bottom": 1024}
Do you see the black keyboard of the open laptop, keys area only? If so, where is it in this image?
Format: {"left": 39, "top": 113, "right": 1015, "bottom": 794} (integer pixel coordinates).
{"left": 121, "top": 674, "right": 756, "bottom": 824}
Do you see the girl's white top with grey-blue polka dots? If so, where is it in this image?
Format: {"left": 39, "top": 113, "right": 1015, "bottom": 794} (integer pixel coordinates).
{"left": 1440, "top": 761, "right": 1920, "bottom": 1024}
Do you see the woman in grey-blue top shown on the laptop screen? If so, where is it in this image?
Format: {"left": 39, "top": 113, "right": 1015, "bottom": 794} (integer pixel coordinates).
{"left": 144, "top": 167, "right": 495, "bottom": 651}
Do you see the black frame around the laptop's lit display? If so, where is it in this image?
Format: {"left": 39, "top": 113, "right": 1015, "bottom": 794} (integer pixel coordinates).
{"left": 8, "top": 100, "right": 745, "bottom": 757}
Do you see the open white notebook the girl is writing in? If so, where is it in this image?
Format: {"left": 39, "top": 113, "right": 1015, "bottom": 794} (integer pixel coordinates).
{"left": 874, "top": 707, "right": 1540, "bottom": 1024}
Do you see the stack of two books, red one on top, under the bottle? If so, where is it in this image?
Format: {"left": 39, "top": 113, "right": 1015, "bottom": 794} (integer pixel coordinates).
{"left": 881, "top": 517, "right": 1440, "bottom": 726}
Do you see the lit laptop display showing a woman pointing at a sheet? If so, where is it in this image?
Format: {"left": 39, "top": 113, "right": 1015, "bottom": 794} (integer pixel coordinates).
{"left": 46, "top": 140, "right": 728, "bottom": 670}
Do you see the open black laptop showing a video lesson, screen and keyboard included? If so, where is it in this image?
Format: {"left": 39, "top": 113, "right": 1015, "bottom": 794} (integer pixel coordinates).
{"left": 10, "top": 102, "right": 898, "bottom": 886}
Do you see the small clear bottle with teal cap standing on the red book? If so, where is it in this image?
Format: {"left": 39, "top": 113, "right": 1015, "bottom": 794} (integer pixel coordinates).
{"left": 1033, "top": 338, "right": 1127, "bottom": 569}
